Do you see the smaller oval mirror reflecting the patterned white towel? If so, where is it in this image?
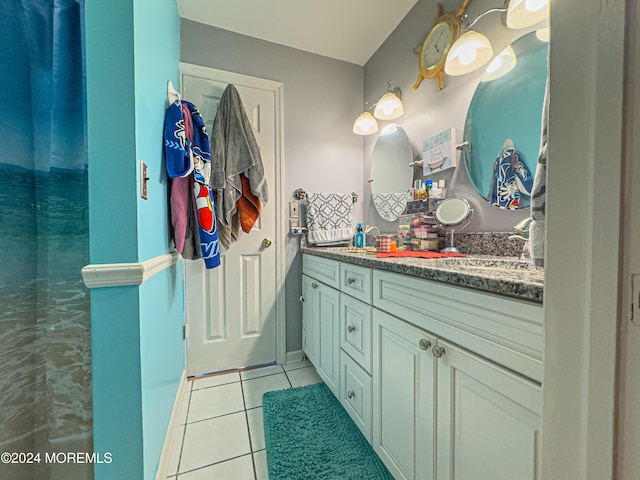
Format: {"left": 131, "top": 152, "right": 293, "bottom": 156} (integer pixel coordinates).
{"left": 369, "top": 123, "right": 413, "bottom": 222}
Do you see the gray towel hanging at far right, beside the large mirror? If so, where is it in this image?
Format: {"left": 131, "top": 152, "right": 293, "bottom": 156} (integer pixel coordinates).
{"left": 529, "top": 77, "right": 549, "bottom": 267}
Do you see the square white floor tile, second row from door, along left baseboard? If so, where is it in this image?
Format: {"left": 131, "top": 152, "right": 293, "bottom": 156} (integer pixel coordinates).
{"left": 187, "top": 383, "right": 244, "bottom": 423}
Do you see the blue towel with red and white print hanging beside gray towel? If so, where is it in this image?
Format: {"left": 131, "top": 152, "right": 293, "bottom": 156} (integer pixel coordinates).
{"left": 164, "top": 100, "right": 220, "bottom": 268}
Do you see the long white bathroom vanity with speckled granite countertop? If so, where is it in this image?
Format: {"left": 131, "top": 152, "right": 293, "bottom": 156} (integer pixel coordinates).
{"left": 302, "top": 248, "right": 544, "bottom": 480}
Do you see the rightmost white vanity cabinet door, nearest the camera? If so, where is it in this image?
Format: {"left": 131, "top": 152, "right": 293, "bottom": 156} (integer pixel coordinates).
{"left": 436, "top": 340, "right": 542, "bottom": 480}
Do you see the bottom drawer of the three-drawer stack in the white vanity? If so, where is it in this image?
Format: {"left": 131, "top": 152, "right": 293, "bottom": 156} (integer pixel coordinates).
{"left": 340, "top": 351, "right": 372, "bottom": 443}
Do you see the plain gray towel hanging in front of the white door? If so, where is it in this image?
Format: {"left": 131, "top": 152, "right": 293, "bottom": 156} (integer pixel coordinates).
{"left": 211, "top": 84, "right": 269, "bottom": 231}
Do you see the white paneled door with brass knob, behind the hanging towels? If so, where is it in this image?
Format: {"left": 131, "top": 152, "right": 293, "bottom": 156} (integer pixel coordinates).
{"left": 182, "top": 68, "right": 283, "bottom": 376}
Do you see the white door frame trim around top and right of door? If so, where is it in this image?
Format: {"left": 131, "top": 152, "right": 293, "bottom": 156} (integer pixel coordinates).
{"left": 179, "top": 62, "right": 287, "bottom": 364}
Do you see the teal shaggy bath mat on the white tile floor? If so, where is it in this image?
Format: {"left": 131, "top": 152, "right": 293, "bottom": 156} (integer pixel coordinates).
{"left": 262, "top": 383, "right": 393, "bottom": 480}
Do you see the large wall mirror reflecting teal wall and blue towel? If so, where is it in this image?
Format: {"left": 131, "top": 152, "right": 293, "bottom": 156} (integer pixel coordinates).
{"left": 463, "top": 32, "right": 548, "bottom": 210}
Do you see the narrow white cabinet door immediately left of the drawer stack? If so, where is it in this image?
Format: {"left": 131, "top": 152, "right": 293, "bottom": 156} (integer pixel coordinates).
{"left": 312, "top": 283, "right": 340, "bottom": 398}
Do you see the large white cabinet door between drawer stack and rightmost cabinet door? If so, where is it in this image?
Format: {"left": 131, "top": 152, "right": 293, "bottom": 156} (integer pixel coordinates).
{"left": 373, "top": 310, "right": 438, "bottom": 480}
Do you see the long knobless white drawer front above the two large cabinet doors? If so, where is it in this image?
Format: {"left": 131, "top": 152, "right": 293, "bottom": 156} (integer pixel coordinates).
{"left": 373, "top": 270, "right": 544, "bottom": 382}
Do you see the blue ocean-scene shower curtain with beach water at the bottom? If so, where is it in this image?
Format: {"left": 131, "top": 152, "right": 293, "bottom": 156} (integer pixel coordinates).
{"left": 0, "top": 0, "right": 93, "bottom": 480}
